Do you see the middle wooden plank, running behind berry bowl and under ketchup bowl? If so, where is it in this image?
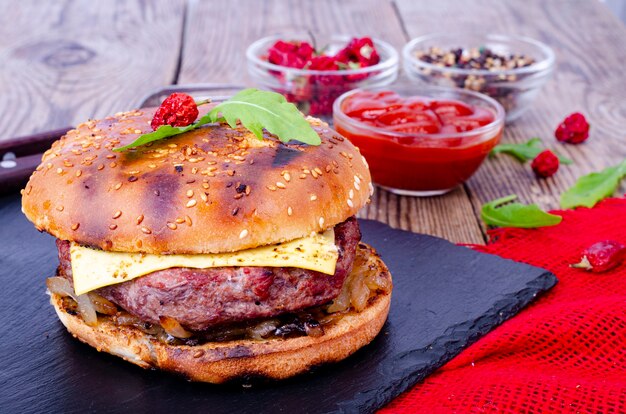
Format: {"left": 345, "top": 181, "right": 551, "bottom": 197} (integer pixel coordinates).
{"left": 179, "top": 0, "right": 483, "bottom": 243}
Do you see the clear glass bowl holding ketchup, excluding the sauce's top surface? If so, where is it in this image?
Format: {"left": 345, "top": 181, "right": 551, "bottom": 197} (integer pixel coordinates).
{"left": 333, "top": 85, "right": 504, "bottom": 196}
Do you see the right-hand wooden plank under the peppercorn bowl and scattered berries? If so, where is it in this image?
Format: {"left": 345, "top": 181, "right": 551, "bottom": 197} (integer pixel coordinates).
{"left": 397, "top": 0, "right": 626, "bottom": 226}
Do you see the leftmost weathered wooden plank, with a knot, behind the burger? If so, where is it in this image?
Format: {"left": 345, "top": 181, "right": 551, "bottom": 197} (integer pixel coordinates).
{"left": 0, "top": 0, "right": 184, "bottom": 139}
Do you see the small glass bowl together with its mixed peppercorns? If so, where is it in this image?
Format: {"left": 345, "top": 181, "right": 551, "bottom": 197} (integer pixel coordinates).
{"left": 402, "top": 34, "right": 555, "bottom": 122}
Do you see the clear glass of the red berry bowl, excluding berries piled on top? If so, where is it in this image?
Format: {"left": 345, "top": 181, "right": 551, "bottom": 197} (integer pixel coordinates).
{"left": 246, "top": 34, "right": 399, "bottom": 120}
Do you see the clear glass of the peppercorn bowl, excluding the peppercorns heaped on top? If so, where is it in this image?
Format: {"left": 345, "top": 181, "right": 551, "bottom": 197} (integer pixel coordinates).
{"left": 402, "top": 33, "right": 555, "bottom": 122}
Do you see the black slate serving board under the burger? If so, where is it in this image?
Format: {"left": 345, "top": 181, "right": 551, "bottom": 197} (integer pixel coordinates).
{"left": 0, "top": 195, "right": 556, "bottom": 413}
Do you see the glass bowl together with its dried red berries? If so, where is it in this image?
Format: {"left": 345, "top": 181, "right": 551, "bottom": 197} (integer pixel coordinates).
{"left": 246, "top": 36, "right": 398, "bottom": 117}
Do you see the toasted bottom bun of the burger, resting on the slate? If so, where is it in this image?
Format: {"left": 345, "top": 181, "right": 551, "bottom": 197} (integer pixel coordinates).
{"left": 50, "top": 244, "right": 391, "bottom": 383}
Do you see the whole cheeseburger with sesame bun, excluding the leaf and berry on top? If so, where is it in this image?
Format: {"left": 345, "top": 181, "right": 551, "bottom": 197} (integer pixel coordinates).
{"left": 22, "top": 95, "right": 392, "bottom": 383}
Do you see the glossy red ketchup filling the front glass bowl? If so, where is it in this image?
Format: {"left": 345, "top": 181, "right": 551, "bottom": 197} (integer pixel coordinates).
{"left": 334, "top": 91, "right": 502, "bottom": 192}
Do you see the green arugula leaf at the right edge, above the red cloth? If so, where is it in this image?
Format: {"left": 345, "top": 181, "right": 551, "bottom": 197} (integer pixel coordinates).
{"left": 561, "top": 160, "right": 626, "bottom": 208}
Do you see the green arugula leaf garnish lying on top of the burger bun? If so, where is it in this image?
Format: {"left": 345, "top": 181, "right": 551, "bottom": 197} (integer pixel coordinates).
{"left": 113, "top": 88, "right": 321, "bottom": 151}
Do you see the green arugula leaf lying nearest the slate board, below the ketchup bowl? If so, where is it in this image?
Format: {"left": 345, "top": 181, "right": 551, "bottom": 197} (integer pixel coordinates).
{"left": 480, "top": 194, "right": 563, "bottom": 228}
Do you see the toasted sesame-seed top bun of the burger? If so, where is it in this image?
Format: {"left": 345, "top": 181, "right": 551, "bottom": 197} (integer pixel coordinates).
{"left": 22, "top": 107, "right": 372, "bottom": 254}
